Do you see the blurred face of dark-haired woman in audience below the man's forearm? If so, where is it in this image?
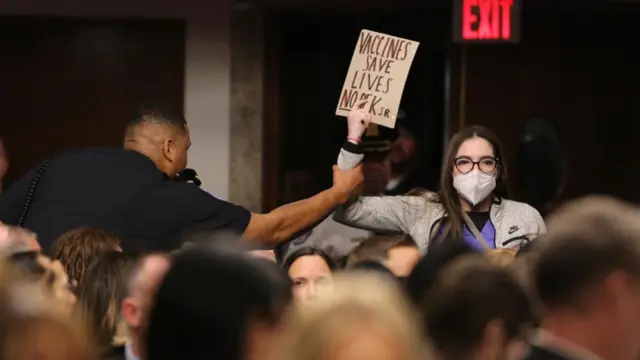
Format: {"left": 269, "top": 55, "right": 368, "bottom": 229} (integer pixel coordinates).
{"left": 289, "top": 255, "right": 331, "bottom": 301}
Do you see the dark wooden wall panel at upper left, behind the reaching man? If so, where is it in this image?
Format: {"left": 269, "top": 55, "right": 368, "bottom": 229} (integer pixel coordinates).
{"left": 0, "top": 17, "right": 185, "bottom": 186}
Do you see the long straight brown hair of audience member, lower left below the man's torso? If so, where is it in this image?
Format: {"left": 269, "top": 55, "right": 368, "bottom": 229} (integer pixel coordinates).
{"left": 77, "top": 251, "right": 138, "bottom": 349}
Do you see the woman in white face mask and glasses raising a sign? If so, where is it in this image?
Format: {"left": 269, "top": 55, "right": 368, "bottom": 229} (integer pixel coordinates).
{"left": 335, "top": 102, "right": 546, "bottom": 252}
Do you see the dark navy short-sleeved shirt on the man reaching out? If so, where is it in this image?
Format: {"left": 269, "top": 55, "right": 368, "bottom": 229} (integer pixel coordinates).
{"left": 0, "top": 148, "right": 251, "bottom": 251}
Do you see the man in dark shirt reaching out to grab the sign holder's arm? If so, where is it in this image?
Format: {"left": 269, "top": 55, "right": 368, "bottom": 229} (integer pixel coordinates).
{"left": 0, "top": 102, "right": 362, "bottom": 251}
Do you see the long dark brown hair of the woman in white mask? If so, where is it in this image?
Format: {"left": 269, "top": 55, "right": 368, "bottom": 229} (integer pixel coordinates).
{"left": 432, "top": 125, "right": 509, "bottom": 243}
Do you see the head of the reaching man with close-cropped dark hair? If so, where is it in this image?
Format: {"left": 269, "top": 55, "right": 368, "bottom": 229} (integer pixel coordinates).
{"left": 124, "top": 104, "right": 191, "bottom": 177}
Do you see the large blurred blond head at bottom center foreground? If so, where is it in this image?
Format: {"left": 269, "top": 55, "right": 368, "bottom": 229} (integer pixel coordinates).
{"left": 281, "top": 272, "right": 428, "bottom": 360}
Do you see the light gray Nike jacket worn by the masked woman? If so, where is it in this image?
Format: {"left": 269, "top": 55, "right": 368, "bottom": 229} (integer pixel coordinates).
{"left": 334, "top": 148, "right": 546, "bottom": 253}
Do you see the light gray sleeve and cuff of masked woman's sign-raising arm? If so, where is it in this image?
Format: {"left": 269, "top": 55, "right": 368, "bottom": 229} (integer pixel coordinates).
{"left": 333, "top": 143, "right": 427, "bottom": 233}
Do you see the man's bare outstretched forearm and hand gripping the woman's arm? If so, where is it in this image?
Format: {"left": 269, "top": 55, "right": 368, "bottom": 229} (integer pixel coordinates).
{"left": 242, "top": 166, "right": 363, "bottom": 247}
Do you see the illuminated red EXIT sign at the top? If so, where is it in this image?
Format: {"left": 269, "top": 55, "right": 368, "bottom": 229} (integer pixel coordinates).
{"left": 462, "top": 0, "right": 513, "bottom": 40}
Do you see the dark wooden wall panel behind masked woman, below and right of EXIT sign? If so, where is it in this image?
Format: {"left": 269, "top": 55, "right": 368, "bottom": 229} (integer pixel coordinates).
{"left": 450, "top": 5, "right": 640, "bottom": 201}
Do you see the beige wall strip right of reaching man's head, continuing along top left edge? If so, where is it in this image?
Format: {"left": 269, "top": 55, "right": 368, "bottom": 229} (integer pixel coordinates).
{"left": 0, "top": 0, "right": 236, "bottom": 199}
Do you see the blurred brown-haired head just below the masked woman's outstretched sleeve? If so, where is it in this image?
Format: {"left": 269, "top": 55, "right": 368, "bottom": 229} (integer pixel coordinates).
{"left": 346, "top": 235, "right": 420, "bottom": 277}
